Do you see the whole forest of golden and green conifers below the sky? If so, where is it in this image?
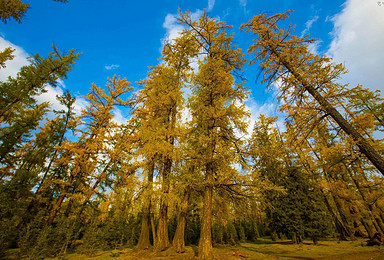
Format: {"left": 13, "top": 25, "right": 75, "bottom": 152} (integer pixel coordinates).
{"left": 0, "top": 0, "right": 384, "bottom": 259}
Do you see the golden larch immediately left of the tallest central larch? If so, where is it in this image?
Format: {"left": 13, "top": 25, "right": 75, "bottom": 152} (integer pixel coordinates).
{"left": 137, "top": 31, "right": 197, "bottom": 251}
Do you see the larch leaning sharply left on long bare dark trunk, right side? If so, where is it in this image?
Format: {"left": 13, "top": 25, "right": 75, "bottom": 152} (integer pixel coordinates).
{"left": 242, "top": 12, "right": 384, "bottom": 175}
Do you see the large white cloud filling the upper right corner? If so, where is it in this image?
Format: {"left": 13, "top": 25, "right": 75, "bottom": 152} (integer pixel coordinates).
{"left": 328, "top": 0, "right": 384, "bottom": 91}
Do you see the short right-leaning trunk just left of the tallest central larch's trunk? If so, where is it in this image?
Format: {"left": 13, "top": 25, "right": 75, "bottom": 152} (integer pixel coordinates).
{"left": 172, "top": 186, "right": 191, "bottom": 253}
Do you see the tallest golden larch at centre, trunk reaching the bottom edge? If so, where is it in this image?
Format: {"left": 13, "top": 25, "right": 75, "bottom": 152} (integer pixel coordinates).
{"left": 179, "top": 10, "right": 248, "bottom": 259}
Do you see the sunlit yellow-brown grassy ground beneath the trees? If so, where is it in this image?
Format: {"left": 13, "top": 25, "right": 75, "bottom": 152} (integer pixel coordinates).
{"left": 40, "top": 238, "right": 384, "bottom": 260}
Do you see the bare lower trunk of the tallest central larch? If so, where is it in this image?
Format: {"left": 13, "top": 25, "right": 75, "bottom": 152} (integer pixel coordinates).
{"left": 198, "top": 163, "right": 213, "bottom": 260}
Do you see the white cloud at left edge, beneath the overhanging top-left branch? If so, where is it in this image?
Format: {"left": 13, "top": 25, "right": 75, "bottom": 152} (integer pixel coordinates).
{"left": 0, "top": 37, "right": 29, "bottom": 81}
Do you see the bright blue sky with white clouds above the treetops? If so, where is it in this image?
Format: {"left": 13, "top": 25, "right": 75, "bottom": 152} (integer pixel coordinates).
{"left": 0, "top": 0, "right": 384, "bottom": 129}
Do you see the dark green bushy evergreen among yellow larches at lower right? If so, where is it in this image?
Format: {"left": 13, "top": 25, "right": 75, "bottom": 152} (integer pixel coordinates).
{"left": 266, "top": 167, "right": 330, "bottom": 243}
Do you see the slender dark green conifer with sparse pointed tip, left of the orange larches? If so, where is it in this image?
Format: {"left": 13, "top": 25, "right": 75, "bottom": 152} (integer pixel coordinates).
{"left": 14, "top": 91, "right": 79, "bottom": 227}
